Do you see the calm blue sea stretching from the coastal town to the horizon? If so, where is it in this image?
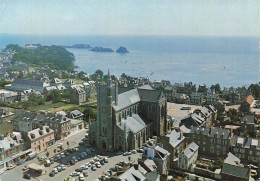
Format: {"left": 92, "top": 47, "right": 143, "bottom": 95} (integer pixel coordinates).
{"left": 0, "top": 34, "right": 260, "bottom": 88}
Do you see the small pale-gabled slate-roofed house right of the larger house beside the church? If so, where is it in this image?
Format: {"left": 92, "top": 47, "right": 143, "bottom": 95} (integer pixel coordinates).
{"left": 178, "top": 142, "right": 199, "bottom": 170}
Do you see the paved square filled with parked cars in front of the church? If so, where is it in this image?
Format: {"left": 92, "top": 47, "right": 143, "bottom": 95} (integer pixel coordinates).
{"left": 0, "top": 131, "right": 141, "bottom": 181}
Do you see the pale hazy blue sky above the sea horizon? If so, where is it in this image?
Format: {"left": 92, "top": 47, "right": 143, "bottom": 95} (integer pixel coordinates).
{"left": 0, "top": 0, "right": 260, "bottom": 36}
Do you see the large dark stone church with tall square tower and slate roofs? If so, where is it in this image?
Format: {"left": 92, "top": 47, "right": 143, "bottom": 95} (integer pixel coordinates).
{"left": 89, "top": 71, "right": 172, "bottom": 151}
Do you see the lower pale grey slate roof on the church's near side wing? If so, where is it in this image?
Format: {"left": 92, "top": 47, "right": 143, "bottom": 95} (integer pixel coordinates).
{"left": 118, "top": 114, "right": 146, "bottom": 133}
